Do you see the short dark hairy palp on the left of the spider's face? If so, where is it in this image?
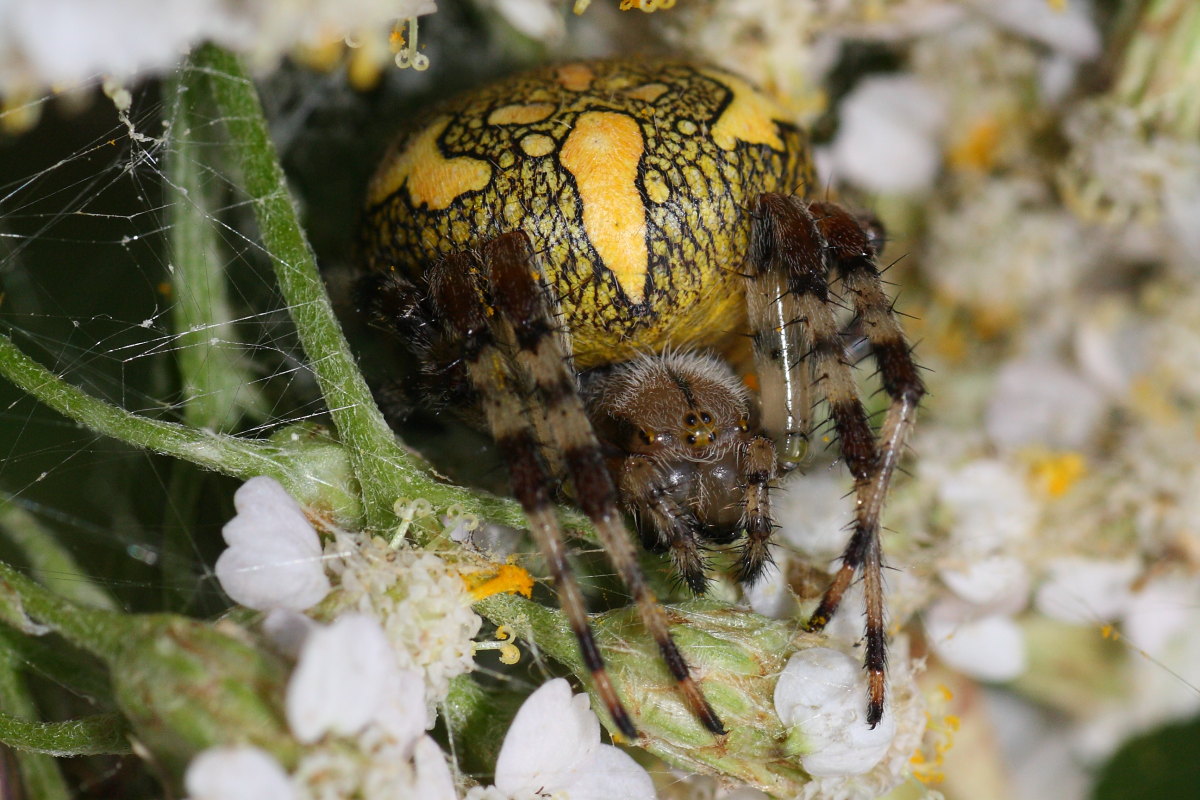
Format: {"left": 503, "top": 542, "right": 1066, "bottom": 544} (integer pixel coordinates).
{"left": 620, "top": 453, "right": 710, "bottom": 595}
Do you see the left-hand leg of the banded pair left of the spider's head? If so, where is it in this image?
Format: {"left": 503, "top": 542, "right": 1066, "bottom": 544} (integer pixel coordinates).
{"left": 430, "top": 253, "right": 637, "bottom": 739}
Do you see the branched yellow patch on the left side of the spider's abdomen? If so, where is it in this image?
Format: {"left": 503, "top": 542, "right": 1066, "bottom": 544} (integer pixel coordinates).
{"left": 368, "top": 119, "right": 492, "bottom": 211}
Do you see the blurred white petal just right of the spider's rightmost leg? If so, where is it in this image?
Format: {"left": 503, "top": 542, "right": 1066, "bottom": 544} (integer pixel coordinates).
{"left": 924, "top": 597, "right": 1027, "bottom": 682}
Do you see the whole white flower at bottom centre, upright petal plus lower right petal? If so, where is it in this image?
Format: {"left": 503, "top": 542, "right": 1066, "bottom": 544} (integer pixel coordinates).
{"left": 480, "top": 678, "right": 655, "bottom": 800}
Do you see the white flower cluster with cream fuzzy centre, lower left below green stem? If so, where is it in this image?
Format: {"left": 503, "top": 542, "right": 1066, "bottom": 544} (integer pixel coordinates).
{"left": 208, "top": 477, "right": 655, "bottom": 800}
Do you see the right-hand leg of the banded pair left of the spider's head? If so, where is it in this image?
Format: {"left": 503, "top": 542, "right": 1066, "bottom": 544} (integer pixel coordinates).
{"left": 482, "top": 231, "right": 725, "bottom": 735}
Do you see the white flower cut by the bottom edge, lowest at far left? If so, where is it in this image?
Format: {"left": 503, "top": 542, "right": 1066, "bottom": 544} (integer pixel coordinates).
{"left": 184, "top": 746, "right": 296, "bottom": 800}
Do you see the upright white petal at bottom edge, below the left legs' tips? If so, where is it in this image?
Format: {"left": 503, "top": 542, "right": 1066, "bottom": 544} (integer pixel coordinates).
{"left": 496, "top": 678, "right": 600, "bottom": 798}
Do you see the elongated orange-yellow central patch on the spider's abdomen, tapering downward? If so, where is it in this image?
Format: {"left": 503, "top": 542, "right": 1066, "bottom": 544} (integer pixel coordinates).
{"left": 559, "top": 112, "right": 649, "bottom": 302}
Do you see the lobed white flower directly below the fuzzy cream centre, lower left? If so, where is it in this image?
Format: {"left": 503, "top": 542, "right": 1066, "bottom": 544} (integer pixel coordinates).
{"left": 287, "top": 614, "right": 428, "bottom": 750}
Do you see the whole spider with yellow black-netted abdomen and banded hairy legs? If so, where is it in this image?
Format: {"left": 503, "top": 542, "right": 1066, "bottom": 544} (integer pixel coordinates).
{"left": 352, "top": 60, "right": 924, "bottom": 739}
